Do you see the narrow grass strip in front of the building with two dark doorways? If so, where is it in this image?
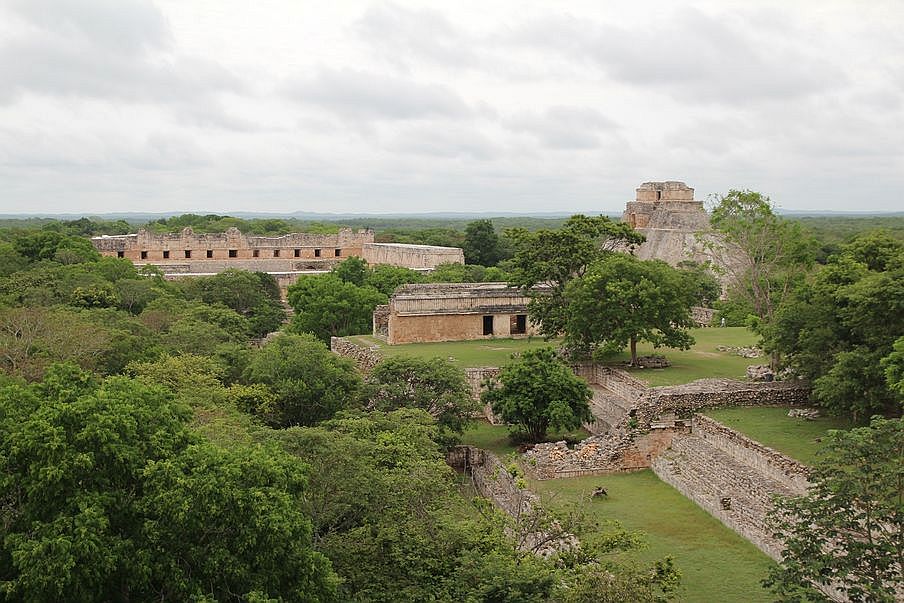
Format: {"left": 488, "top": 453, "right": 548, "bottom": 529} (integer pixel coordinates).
{"left": 346, "top": 335, "right": 559, "bottom": 368}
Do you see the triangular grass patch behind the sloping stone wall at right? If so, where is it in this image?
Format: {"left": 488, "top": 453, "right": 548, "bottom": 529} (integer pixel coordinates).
{"left": 704, "top": 406, "right": 854, "bottom": 464}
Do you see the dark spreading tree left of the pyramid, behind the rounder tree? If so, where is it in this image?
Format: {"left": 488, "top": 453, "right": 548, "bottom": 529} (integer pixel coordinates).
{"left": 506, "top": 215, "right": 644, "bottom": 337}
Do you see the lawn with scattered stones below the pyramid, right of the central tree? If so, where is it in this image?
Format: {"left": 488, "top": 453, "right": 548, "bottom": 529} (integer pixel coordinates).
{"left": 616, "top": 327, "right": 768, "bottom": 386}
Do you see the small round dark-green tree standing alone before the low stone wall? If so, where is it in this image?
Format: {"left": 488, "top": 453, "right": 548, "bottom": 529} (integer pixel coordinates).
{"left": 482, "top": 348, "right": 593, "bottom": 442}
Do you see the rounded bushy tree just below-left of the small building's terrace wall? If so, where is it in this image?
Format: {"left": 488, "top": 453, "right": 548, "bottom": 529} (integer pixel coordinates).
{"left": 245, "top": 335, "right": 363, "bottom": 427}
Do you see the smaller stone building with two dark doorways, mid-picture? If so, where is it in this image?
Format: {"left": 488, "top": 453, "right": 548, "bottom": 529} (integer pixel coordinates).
{"left": 374, "top": 283, "right": 536, "bottom": 345}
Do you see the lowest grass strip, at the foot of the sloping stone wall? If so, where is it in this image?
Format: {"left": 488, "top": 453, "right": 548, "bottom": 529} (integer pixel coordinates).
{"left": 530, "top": 470, "right": 772, "bottom": 603}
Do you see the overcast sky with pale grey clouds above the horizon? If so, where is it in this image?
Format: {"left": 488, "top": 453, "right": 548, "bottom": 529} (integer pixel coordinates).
{"left": 0, "top": 0, "right": 904, "bottom": 213}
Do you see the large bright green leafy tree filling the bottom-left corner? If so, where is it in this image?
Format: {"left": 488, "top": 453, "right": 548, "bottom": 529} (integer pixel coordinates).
{"left": 0, "top": 365, "right": 336, "bottom": 601}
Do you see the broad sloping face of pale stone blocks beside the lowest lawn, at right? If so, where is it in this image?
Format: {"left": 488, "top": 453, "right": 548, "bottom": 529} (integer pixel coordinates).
{"left": 652, "top": 415, "right": 808, "bottom": 560}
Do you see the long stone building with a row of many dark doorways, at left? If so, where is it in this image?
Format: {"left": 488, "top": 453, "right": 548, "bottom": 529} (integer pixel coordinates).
{"left": 91, "top": 228, "right": 464, "bottom": 293}
